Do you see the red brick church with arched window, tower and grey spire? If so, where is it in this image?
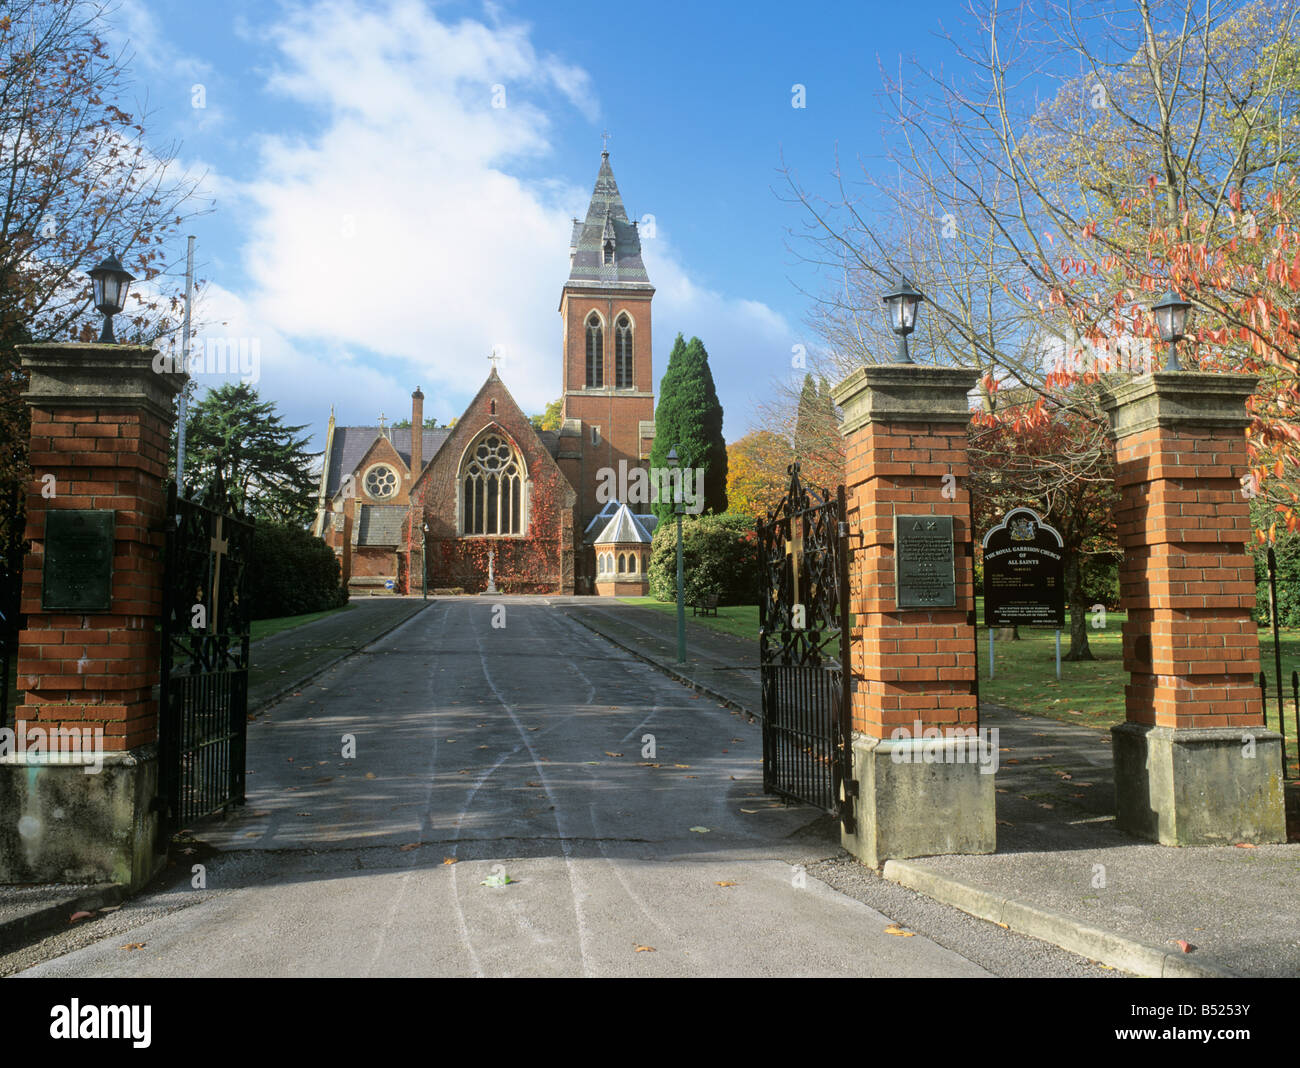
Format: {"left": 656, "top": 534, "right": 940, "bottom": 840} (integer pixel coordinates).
{"left": 315, "top": 152, "right": 655, "bottom": 595}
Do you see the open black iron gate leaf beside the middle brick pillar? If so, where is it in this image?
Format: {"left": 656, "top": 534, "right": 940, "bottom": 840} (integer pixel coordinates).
{"left": 758, "top": 463, "right": 855, "bottom": 833}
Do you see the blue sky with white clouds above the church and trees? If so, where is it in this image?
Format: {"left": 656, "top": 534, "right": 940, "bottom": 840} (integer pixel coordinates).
{"left": 116, "top": 0, "right": 969, "bottom": 447}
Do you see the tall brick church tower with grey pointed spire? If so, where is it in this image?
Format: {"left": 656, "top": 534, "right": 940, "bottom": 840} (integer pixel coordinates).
{"left": 556, "top": 152, "right": 654, "bottom": 538}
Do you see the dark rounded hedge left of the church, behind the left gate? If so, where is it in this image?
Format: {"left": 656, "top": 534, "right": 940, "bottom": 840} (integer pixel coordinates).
{"left": 244, "top": 521, "right": 347, "bottom": 620}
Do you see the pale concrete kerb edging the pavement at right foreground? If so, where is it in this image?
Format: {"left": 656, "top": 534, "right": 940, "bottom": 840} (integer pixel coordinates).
{"left": 883, "top": 860, "right": 1239, "bottom": 978}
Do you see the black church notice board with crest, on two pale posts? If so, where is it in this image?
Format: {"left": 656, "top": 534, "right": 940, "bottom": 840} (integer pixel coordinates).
{"left": 983, "top": 508, "right": 1065, "bottom": 678}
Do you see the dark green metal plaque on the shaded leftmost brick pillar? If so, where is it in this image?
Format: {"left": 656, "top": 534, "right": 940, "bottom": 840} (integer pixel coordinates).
{"left": 40, "top": 508, "right": 116, "bottom": 612}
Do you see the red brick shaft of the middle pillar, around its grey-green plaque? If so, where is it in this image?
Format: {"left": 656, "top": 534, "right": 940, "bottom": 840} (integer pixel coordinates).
{"left": 846, "top": 422, "right": 978, "bottom": 738}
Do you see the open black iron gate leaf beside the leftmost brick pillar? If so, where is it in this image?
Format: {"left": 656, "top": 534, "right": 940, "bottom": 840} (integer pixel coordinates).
{"left": 159, "top": 482, "right": 252, "bottom": 830}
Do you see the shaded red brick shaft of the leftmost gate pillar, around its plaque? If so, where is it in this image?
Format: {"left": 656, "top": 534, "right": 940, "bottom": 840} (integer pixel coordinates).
{"left": 17, "top": 408, "right": 168, "bottom": 750}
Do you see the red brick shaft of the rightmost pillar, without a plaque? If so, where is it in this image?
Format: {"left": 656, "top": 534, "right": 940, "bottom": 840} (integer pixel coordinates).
{"left": 1115, "top": 427, "right": 1264, "bottom": 728}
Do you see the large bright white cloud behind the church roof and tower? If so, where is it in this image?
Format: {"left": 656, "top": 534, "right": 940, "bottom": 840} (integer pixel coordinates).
{"left": 209, "top": 0, "right": 790, "bottom": 437}
